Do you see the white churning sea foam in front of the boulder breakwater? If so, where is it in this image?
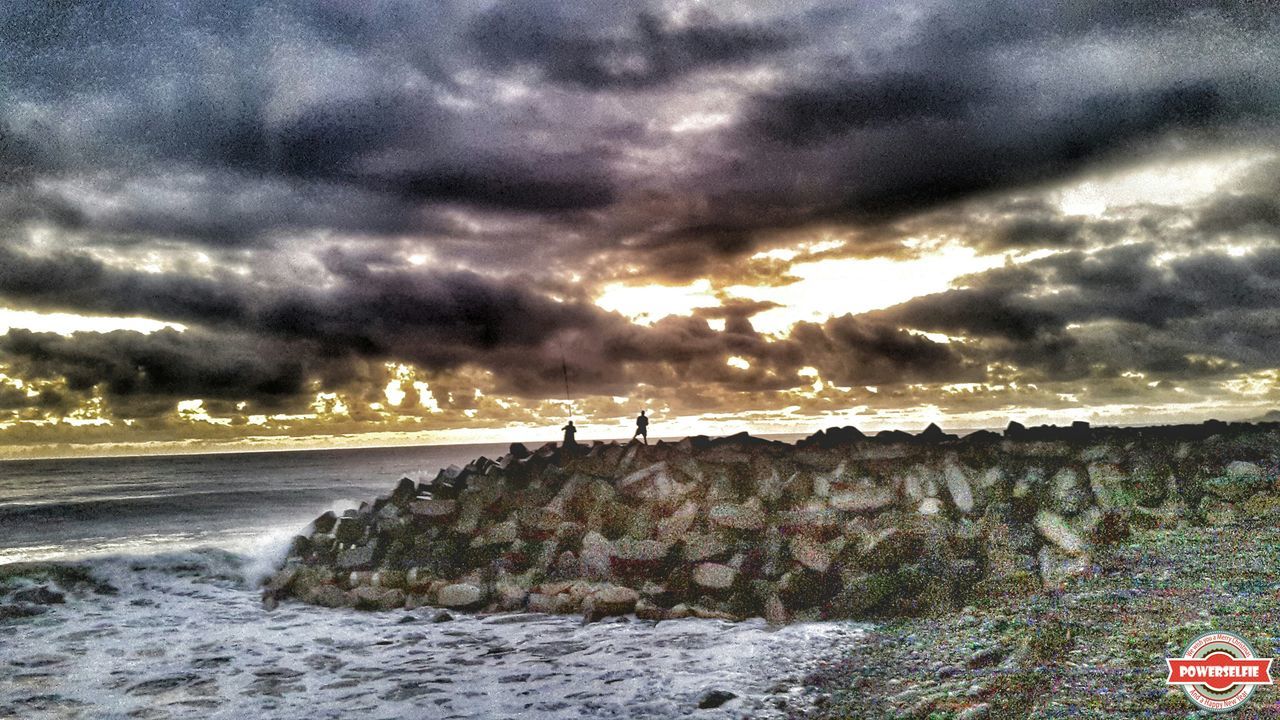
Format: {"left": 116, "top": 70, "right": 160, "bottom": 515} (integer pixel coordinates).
{"left": 0, "top": 545, "right": 865, "bottom": 720}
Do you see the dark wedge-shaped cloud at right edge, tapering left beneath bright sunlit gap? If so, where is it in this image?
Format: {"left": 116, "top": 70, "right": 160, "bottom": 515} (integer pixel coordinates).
{"left": 870, "top": 238, "right": 1280, "bottom": 378}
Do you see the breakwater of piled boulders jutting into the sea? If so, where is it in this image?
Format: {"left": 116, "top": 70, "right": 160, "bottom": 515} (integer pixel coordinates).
{"left": 264, "top": 423, "right": 1280, "bottom": 623}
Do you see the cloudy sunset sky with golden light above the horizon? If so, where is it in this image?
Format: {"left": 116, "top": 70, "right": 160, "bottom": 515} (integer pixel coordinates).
{"left": 0, "top": 0, "right": 1280, "bottom": 457}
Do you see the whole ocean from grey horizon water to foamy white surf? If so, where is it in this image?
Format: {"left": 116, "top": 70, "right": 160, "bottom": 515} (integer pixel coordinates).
{"left": 0, "top": 445, "right": 867, "bottom": 720}
